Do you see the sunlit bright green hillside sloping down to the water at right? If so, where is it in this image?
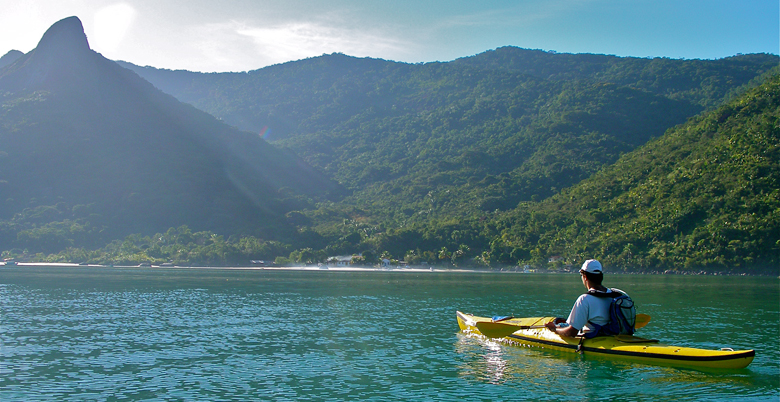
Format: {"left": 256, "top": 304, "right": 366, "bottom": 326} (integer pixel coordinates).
{"left": 499, "top": 73, "right": 780, "bottom": 275}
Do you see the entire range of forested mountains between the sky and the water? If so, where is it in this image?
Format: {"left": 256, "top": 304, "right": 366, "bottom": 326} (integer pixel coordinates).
{"left": 0, "top": 16, "right": 780, "bottom": 270}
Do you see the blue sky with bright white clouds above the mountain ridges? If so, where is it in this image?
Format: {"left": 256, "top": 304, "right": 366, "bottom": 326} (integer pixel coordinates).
{"left": 0, "top": 0, "right": 780, "bottom": 72}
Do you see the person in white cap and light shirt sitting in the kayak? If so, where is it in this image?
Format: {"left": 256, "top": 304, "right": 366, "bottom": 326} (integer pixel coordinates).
{"left": 545, "top": 260, "right": 612, "bottom": 338}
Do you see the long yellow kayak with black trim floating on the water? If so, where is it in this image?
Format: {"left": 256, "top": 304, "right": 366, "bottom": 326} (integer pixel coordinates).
{"left": 457, "top": 311, "right": 756, "bottom": 369}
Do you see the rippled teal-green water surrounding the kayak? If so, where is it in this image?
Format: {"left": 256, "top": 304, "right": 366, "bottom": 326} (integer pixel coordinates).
{"left": 0, "top": 267, "right": 780, "bottom": 401}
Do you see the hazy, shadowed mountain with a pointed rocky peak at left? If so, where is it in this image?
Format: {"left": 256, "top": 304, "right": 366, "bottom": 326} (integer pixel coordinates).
{"left": 0, "top": 17, "right": 342, "bottom": 251}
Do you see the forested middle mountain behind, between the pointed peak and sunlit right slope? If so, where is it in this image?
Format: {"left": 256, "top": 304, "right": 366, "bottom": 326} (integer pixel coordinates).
{"left": 125, "top": 48, "right": 778, "bottom": 226}
